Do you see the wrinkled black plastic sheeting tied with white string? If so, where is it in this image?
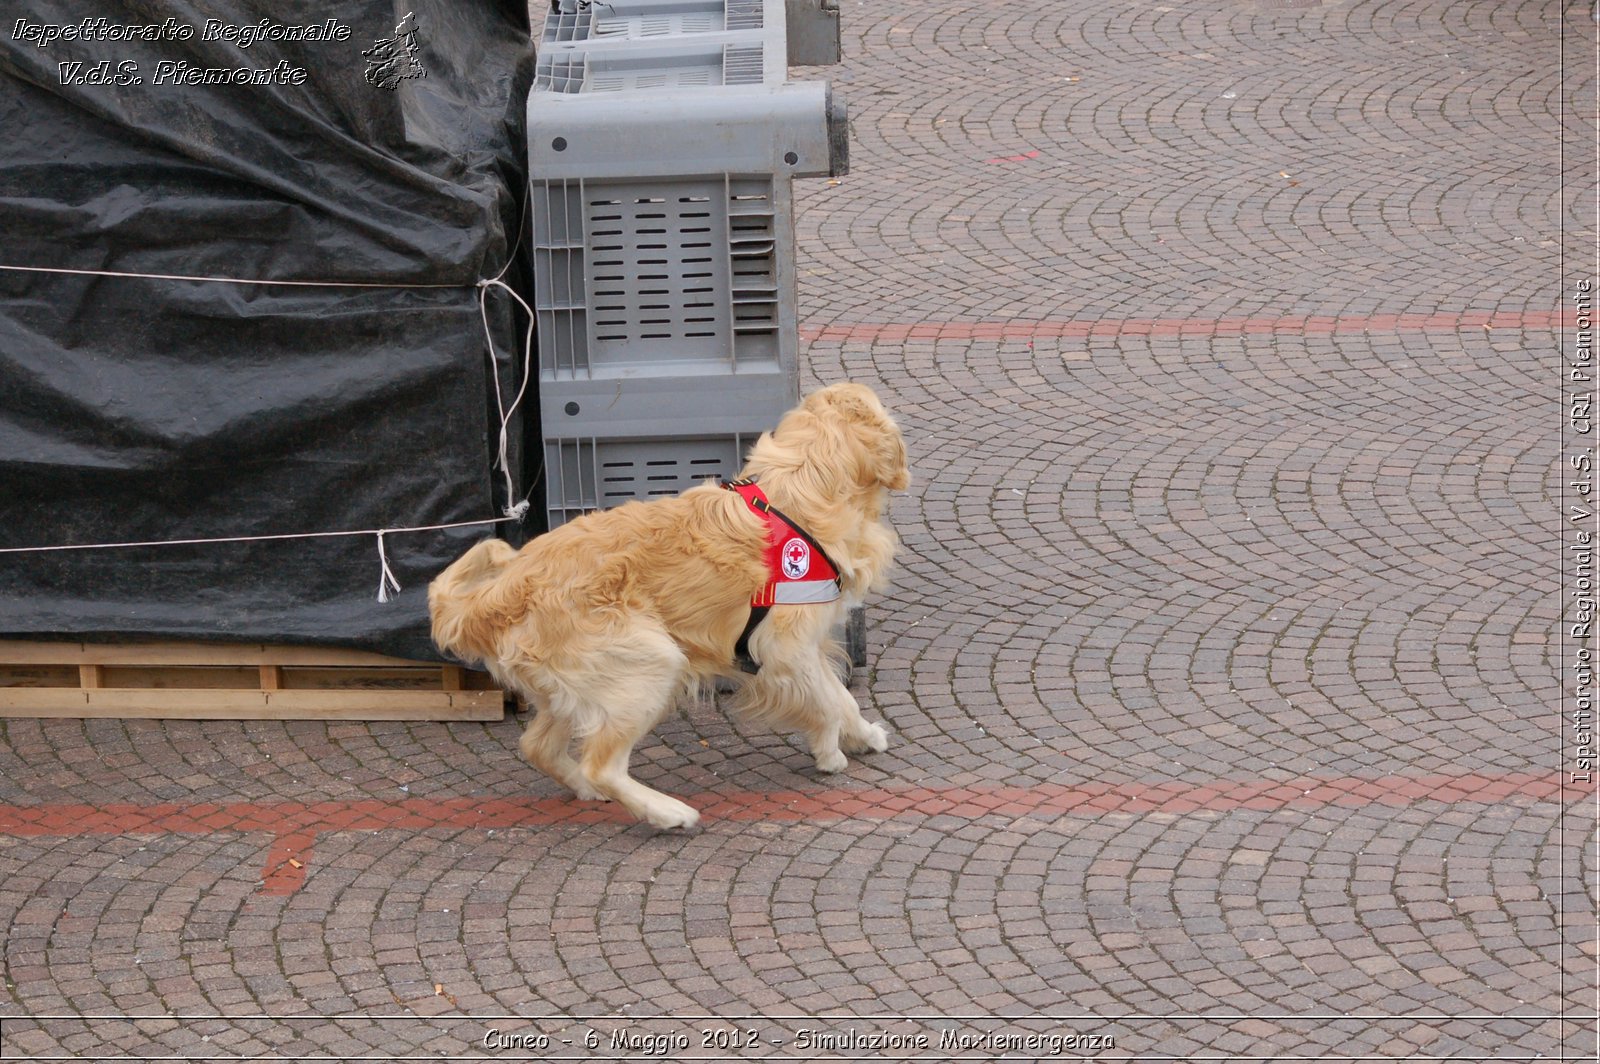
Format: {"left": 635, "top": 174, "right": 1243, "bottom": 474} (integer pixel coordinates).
{"left": 0, "top": 0, "right": 538, "bottom": 658}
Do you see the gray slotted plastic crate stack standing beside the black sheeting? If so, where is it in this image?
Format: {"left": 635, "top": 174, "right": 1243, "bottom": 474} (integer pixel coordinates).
{"left": 528, "top": 0, "right": 846, "bottom": 528}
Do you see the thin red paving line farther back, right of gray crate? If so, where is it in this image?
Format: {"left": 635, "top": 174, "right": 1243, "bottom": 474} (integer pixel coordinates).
{"left": 800, "top": 310, "right": 1578, "bottom": 342}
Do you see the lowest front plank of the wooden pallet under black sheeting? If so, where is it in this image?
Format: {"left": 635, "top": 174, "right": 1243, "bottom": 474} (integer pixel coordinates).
{"left": 0, "top": 688, "right": 506, "bottom": 720}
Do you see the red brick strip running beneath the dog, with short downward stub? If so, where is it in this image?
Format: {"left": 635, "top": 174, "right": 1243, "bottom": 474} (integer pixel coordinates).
{"left": 0, "top": 773, "right": 1568, "bottom": 894}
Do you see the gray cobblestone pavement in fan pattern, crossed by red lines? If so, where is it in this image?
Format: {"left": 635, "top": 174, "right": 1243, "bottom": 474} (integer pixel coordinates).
{"left": 0, "top": 0, "right": 1597, "bottom": 1061}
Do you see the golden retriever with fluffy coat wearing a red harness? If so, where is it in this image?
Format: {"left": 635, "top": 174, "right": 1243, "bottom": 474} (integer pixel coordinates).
{"left": 427, "top": 382, "right": 910, "bottom": 829}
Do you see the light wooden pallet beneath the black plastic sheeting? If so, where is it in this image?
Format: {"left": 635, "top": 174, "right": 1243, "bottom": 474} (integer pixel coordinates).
{"left": 0, "top": 640, "right": 506, "bottom": 720}
